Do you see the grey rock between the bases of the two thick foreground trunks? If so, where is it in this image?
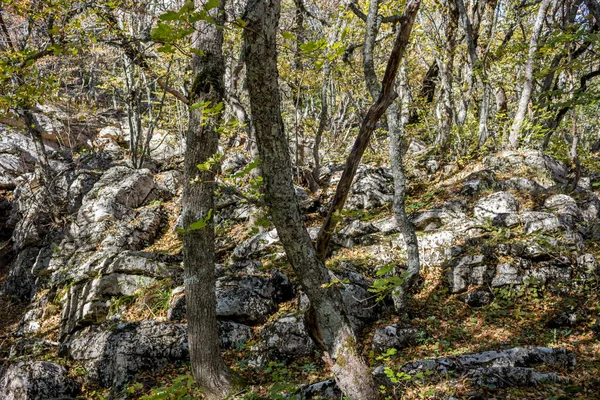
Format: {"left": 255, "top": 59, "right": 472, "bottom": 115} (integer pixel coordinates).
{"left": 260, "top": 315, "right": 315, "bottom": 360}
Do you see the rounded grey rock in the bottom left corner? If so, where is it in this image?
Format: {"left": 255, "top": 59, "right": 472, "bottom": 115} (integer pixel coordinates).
{"left": 0, "top": 361, "right": 81, "bottom": 400}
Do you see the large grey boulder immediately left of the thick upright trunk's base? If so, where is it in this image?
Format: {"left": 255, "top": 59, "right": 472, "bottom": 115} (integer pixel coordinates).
{"left": 66, "top": 321, "right": 189, "bottom": 387}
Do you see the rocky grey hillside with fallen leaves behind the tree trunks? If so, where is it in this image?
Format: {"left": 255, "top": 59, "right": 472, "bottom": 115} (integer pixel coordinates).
{"left": 0, "top": 122, "right": 600, "bottom": 399}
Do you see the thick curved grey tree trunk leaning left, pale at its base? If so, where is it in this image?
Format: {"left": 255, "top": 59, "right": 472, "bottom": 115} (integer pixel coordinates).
{"left": 244, "top": 0, "right": 378, "bottom": 400}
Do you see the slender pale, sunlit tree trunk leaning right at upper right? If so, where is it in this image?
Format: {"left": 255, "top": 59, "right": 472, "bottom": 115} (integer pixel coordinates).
{"left": 508, "top": 0, "right": 551, "bottom": 149}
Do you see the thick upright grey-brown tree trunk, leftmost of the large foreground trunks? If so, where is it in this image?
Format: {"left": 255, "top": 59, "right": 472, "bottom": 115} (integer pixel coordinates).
{"left": 182, "top": 1, "right": 237, "bottom": 399}
